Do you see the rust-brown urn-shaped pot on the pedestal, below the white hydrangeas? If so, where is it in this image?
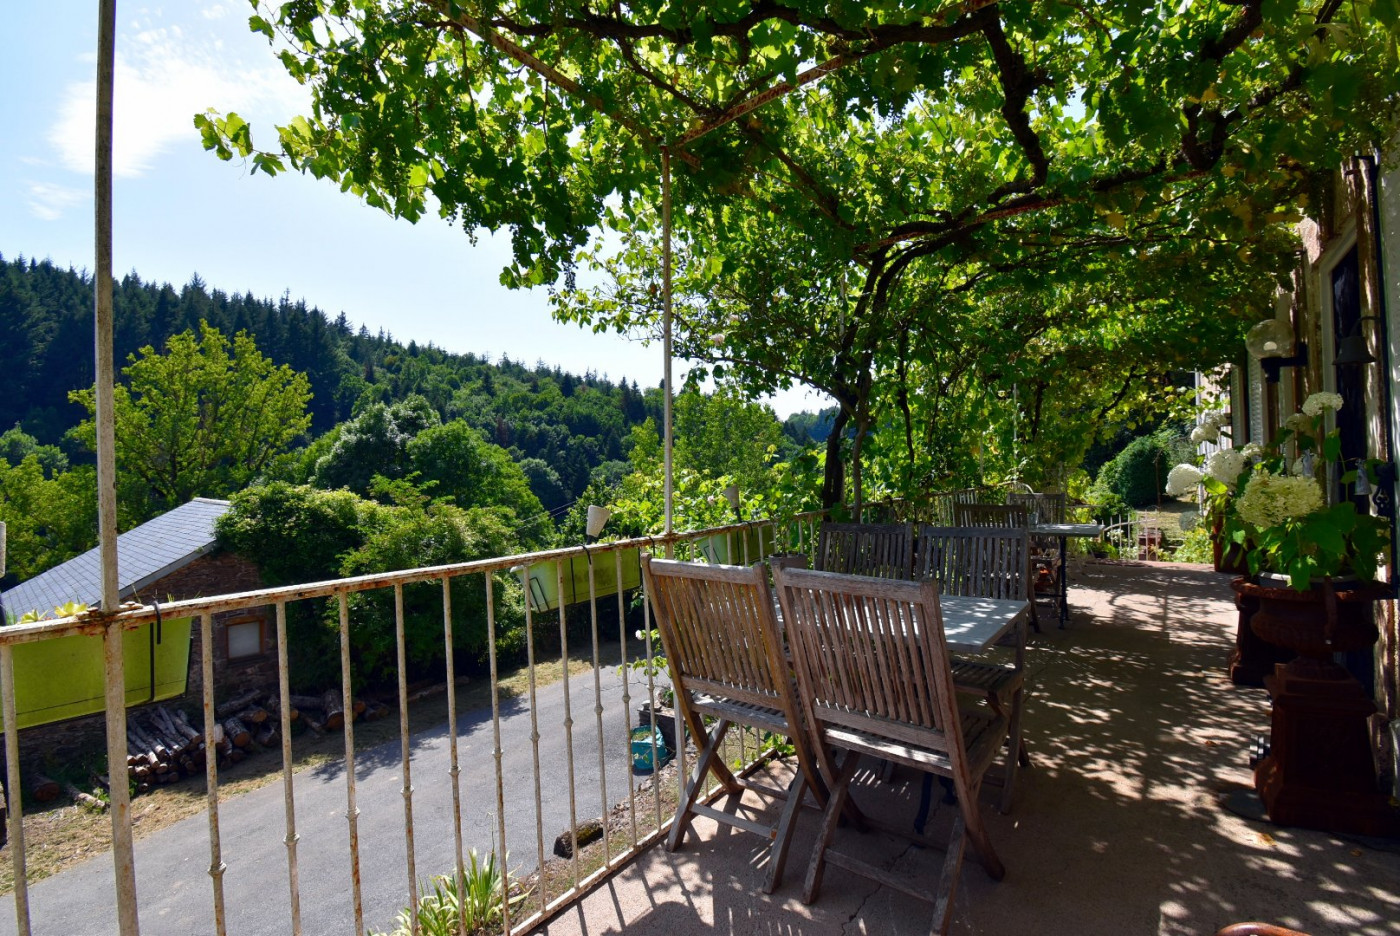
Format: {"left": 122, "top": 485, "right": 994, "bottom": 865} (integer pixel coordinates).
{"left": 1235, "top": 581, "right": 1390, "bottom": 679}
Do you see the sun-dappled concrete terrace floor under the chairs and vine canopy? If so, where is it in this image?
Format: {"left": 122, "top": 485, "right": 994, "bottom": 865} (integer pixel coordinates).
{"left": 540, "top": 564, "right": 1400, "bottom": 936}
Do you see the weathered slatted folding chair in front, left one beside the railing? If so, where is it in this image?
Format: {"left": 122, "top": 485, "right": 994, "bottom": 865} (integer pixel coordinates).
{"left": 641, "top": 557, "right": 827, "bottom": 894}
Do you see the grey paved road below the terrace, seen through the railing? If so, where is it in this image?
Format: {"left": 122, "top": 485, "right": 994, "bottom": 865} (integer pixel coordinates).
{"left": 0, "top": 667, "right": 663, "bottom": 936}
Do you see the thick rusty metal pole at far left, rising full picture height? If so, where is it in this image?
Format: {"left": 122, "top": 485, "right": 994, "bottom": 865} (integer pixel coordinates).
{"left": 92, "top": 0, "right": 140, "bottom": 936}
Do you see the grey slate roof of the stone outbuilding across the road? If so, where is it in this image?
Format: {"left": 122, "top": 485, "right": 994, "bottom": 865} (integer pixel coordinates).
{"left": 0, "top": 497, "right": 228, "bottom": 617}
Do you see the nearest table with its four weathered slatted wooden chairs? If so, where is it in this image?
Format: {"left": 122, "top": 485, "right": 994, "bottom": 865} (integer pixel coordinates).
{"left": 643, "top": 525, "right": 1033, "bottom": 933}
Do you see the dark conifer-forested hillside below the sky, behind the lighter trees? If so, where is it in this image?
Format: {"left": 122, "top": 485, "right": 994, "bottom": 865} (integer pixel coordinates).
{"left": 0, "top": 256, "right": 659, "bottom": 509}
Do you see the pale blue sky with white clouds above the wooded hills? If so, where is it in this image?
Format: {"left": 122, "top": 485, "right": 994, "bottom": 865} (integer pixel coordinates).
{"left": 0, "top": 0, "right": 822, "bottom": 416}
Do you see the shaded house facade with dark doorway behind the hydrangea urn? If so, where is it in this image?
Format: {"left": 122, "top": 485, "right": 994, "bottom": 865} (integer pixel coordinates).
{"left": 1231, "top": 141, "right": 1400, "bottom": 786}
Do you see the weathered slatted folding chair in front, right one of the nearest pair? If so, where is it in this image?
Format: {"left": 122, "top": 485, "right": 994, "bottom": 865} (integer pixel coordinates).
{"left": 773, "top": 568, "right": 1008, "bottom": 933}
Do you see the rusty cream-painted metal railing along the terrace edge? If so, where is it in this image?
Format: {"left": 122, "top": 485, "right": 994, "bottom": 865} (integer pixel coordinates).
{"left": 0, "top": 513, "right": 820, "bottom": 936}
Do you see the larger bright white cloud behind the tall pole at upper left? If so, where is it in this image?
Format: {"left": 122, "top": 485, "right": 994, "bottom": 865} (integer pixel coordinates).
{"left": 48, "top": 18, "right": 307, "bottom": 178}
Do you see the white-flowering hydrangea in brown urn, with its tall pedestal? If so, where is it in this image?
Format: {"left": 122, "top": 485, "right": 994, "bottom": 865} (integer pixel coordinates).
{"left": 1225, "top": 393, "right": 1400, "bottom": 835}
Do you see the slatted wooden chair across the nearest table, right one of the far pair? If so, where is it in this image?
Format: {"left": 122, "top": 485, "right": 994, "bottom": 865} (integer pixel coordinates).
{"left": 914, "top": 526, "right": 1040, "bottom": 813}
